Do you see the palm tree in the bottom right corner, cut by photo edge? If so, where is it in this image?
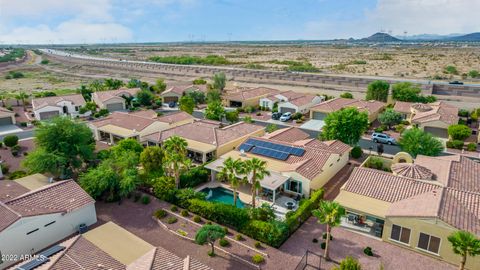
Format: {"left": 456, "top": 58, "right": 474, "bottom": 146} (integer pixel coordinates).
{"left": 447, "top": 231, "right": 480, "bottom": 270}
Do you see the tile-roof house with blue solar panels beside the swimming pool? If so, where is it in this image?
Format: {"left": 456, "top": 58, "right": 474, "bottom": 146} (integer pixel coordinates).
{"left": 206, "top": 128, "right": 351, "bottom": 197}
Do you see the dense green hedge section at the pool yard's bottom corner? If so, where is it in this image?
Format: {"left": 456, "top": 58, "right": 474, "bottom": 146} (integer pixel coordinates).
{"left": 241, "top": 220, "right": 290, "bottom": 247}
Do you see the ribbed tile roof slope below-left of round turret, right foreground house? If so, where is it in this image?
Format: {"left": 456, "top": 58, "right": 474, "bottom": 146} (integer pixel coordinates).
{"left": 343, "top": 167, "right": 438, "bottom": 203}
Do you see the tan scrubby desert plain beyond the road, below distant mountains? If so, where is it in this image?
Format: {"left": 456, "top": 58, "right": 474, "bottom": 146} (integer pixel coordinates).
{"left": 62, "top": 43, "right": 480, "bottom": 80}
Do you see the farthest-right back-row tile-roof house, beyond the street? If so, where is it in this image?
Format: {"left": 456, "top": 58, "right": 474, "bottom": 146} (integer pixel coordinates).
{"left": 393, "top": 101, "right": 459, "bottom": 138}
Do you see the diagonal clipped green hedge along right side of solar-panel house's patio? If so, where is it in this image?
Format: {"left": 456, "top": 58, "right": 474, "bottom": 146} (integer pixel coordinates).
{"left": 285, "top": 189, "right": 323, "bottom": 234}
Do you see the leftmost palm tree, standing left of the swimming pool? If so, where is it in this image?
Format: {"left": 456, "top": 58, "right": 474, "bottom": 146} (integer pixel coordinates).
{"left": 163, "top": 136, "right": 191, "bottom": 188}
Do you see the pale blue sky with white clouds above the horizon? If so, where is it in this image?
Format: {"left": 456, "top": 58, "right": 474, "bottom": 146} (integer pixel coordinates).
{"left": 0, "top": 0, "right": 480, "bottom": 43}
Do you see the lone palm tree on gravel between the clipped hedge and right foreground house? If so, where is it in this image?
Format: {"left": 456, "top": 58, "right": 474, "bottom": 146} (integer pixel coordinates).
{"left": 312, "top": 201, "right": 345, "bottom": 260}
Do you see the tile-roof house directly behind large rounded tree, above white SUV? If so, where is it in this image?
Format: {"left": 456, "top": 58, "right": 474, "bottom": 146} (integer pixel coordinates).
{"left": 310, "top": 98, "right": 387, "bottom": 122}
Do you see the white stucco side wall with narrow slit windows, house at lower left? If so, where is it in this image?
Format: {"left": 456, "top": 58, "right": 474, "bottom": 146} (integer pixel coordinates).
{"left": 0, "top": 203, "right": 97, "bottom": 269}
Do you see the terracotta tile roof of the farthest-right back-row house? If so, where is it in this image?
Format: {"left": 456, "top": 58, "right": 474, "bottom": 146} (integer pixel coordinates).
{"left": 412, "top": 101, "right": 459, "bottom": 125}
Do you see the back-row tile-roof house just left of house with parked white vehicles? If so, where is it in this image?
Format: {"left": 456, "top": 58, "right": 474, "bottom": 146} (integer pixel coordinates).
{"left": 223, "top": 87, "right": 280, "bottom": 108}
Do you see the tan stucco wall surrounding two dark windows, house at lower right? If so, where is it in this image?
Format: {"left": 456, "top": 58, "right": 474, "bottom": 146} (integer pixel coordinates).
{"left": 382, "top": 217, "right": 480, "bottom": 270}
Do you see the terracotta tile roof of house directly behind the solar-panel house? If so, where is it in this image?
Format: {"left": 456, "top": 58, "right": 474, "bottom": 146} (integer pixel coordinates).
{"left": 146, "top": 120, "right": 263, "bottom": 146}
